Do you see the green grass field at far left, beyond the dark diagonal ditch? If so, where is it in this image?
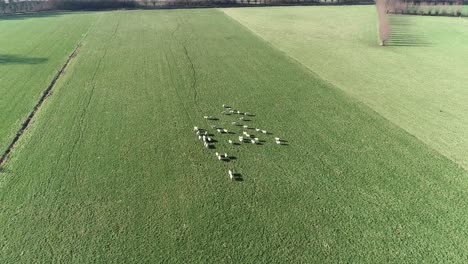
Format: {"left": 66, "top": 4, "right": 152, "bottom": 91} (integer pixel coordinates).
{"left": 0, "top": 13, "right": 98, "bottom": 153}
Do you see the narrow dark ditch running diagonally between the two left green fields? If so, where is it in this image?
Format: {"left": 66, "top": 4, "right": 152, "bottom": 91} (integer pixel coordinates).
{"left": 0, "top": 42, "right": 82, "bottom": 169}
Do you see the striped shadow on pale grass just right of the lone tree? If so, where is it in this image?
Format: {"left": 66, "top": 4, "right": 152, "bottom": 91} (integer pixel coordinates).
{"left": 385, "top": 15, "right": 432, "bottom": 47}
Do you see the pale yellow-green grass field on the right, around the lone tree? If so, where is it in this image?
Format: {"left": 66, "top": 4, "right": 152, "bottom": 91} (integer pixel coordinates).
{"left": 224, "top": 6, "right": 468, "bottom": 169}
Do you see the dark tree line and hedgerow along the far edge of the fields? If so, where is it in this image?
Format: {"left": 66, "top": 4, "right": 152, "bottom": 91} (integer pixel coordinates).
{"left": 0, "top": 0, "right": 468, "bottom": 16}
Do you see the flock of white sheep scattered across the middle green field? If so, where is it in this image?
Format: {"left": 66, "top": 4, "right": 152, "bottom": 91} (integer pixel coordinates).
{"left": 193, "top": 104, "right": 286, "bottom": 180}
